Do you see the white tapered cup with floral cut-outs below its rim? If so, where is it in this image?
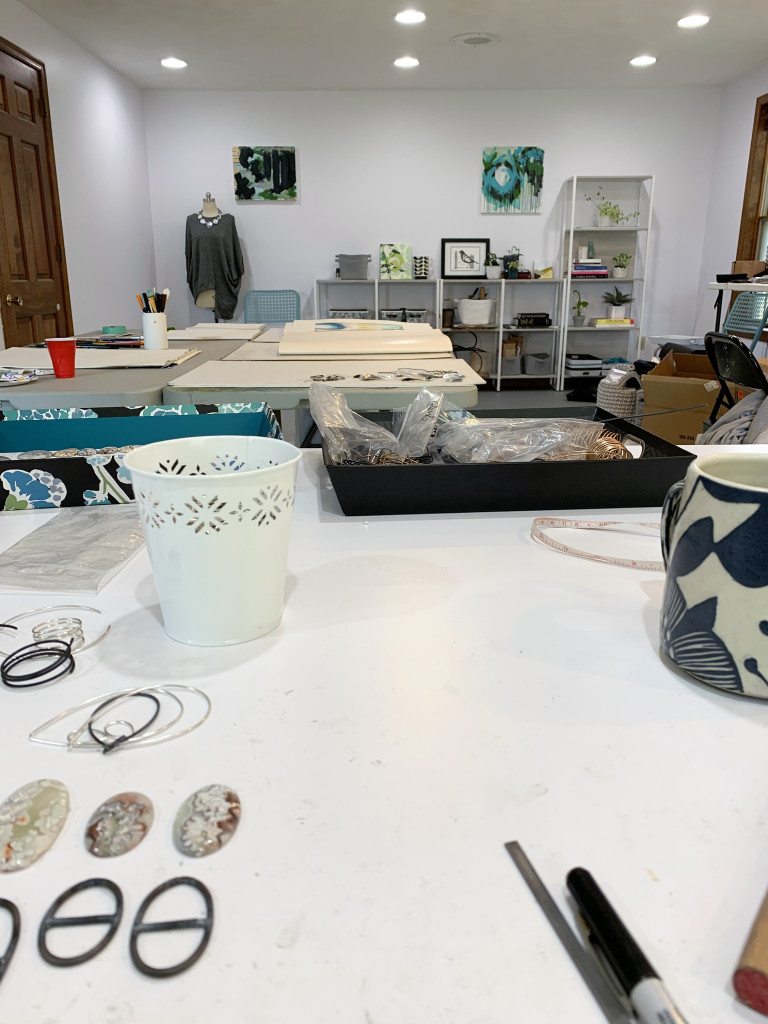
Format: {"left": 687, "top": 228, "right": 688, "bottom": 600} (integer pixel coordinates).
{"left": 125, "top": 434, "right": 301, "bottom": 646}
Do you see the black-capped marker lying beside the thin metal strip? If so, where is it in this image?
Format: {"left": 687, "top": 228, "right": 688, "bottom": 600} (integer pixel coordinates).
{"left": 565, "top": 867, "right": 686, "bottom": 1024}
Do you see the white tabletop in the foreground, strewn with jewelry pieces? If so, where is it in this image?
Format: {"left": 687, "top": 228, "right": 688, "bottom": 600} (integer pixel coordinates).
{"left": 0, "top": 451, "right": 768, "bottom": 1024}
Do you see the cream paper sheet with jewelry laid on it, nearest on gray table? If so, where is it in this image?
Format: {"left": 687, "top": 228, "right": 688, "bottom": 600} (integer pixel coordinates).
{"left": 166, "top": 358, "right": 485, "bottom": 391}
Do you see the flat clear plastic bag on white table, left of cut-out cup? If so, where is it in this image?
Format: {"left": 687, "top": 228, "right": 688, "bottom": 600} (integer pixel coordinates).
{"left": 0, "top": 504, "right": 144, "bottom": 594}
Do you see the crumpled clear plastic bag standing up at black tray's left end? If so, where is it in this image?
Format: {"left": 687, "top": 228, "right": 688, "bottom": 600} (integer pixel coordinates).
{"left": 309, "top": 381, "right": 402, "bottom": 464}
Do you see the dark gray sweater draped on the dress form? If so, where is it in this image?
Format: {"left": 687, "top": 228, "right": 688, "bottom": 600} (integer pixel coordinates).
{"left": 184, "top": 213, "right": 243, "bottom": 319}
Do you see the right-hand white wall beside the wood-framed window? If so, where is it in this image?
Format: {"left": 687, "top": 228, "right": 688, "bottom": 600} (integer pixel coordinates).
{"left": 696, "top": 63, "right": 768, "bottom": 335}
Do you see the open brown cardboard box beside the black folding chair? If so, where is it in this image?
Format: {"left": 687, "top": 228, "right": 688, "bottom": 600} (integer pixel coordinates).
{"left": 642, "top": 352, "right": 729, "bottom": 444}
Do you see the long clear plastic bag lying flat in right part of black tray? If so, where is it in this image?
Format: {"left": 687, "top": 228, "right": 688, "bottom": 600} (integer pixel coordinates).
{"left": 435, "top": 418, "right": 603, "bottom": 464}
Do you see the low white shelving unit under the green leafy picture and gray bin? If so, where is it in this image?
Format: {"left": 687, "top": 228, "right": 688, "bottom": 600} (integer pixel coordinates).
{"left": 314, "top": 278, "right": 442, "bottom": 327}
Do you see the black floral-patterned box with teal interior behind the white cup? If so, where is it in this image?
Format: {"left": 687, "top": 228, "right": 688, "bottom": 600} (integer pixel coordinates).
{"left": 0, "top": 401, "right": 282, "bottom": 512}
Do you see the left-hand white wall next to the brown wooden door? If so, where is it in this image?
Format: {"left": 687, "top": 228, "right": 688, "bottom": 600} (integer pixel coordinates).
{"left": 0, "top": 0, "right": 154, "bottom": 332}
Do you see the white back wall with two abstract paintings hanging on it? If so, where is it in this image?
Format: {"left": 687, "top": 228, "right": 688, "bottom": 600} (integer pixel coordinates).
{"left": 144, "top": 88, "right": 720, "bottom": 335}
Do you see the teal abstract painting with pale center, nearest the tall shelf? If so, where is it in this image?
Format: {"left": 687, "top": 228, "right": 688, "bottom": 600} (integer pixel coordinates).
{"left": 480, "top": 145, "right": 544, "bottom": 213}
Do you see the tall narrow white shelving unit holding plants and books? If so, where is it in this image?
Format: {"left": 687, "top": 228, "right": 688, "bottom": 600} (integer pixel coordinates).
{"left": 556, "top": 174, "right": 653, "bottom": 390}
